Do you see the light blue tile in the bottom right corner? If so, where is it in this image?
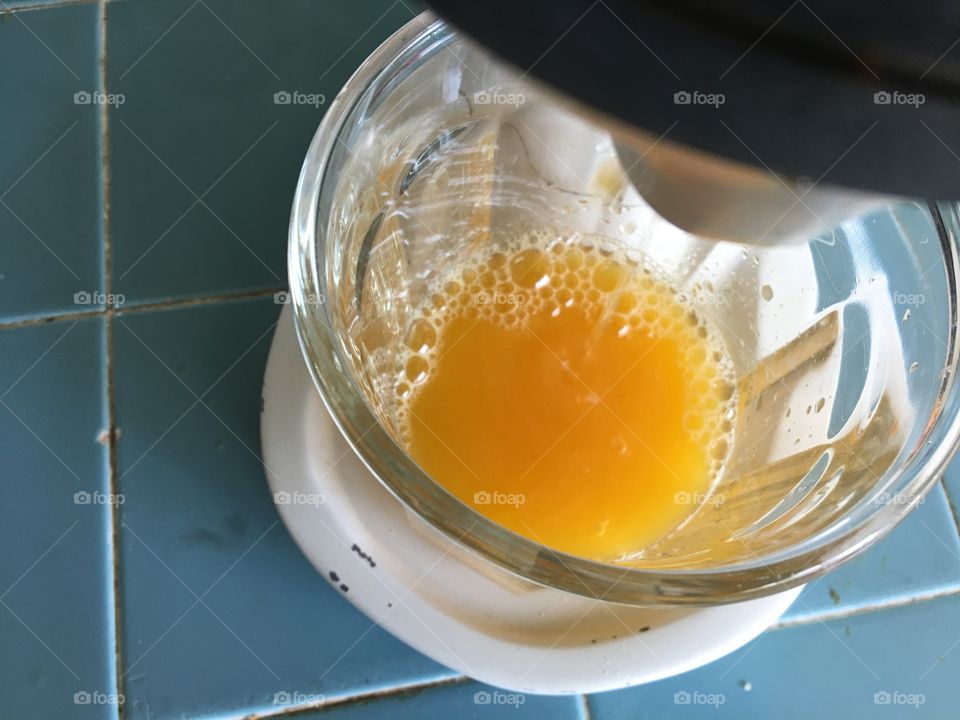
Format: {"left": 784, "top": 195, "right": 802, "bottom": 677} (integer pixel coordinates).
{"left": 589, "top": 598, "right": 960, "bottom": 720}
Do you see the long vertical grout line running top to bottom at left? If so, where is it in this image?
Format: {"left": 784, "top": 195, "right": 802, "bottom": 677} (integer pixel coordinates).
{"left": 97, "top": 0, "right": 124, "bottom": 720}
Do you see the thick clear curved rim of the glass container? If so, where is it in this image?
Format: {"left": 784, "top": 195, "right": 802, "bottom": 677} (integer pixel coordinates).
{"left": 288, "top": 12, "right": 960, "bottom": 606}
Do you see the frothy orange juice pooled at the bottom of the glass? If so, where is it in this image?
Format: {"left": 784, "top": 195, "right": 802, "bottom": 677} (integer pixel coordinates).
{"left": 395, "top": 237, "right": 734, "bottom": 560}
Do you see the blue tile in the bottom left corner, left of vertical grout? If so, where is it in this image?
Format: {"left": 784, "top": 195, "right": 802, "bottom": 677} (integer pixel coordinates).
{"left": 0, "top": 319, "right": 116, "bottom": 720}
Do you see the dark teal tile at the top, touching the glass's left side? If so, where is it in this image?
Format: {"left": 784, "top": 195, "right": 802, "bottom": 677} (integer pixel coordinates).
{"left": 108, "top": 0, "right": 414, "bottom": 302}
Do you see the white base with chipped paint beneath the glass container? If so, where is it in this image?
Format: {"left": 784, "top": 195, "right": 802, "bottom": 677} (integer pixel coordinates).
{"left": 261, "top": 306, "right": 802, "bottom": 694}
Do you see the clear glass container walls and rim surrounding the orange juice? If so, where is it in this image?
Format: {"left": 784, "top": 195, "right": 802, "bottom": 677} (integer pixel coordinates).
{"left": 289, "top": 13, "right": 960, "bottom": 605}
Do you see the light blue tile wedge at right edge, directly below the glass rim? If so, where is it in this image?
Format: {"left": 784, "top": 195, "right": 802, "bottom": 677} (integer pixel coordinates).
{"left": 784, "top": 484, "right": 960, "bottom": 620}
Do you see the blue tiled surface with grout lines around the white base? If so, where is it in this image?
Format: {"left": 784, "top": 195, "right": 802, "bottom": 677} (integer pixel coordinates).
{"left": 0, "top": 0, "right": 960, "bottom": 720}
